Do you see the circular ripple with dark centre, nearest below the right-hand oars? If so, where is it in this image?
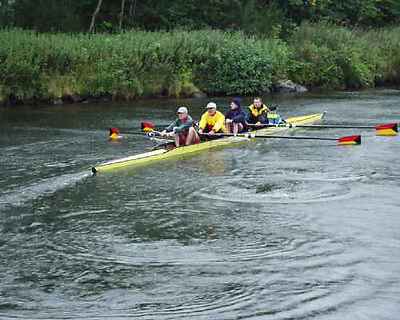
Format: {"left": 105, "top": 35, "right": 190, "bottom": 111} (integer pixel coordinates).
{"left": 196, "top": 171, "right": 362, "bottom": 204}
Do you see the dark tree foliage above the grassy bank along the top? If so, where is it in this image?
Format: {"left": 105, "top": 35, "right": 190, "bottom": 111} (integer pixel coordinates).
{"left": 0, "top": 0, "right": 400, "bottom": 36}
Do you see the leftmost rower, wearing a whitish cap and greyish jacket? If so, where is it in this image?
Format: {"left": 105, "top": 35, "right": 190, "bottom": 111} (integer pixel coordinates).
{"left": 161, "top": 107, "right": 200, "bottom": 147}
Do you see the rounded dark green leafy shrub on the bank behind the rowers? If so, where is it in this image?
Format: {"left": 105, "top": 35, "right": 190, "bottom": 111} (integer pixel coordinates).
{"left": 194, "top": 33, "right": 291, "bottom": 95}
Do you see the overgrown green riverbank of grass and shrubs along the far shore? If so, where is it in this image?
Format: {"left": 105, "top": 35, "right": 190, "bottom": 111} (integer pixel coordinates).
{"left": 0, "top": 24, "right": 400, "bottom": 104}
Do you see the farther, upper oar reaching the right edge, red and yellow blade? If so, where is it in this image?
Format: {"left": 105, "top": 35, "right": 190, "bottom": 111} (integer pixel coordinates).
{"left": 247, "top": 123, "right": 398, "bottom": 136}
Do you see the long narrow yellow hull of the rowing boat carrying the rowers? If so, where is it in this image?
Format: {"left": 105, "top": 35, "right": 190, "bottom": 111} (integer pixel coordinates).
{"left": 92, "top": 113, "right": 324, "bottom": 174}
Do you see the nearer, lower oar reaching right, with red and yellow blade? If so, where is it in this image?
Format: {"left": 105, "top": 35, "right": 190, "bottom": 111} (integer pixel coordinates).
{"left": 201, "top": 132, "right": 361, "bottom": 145}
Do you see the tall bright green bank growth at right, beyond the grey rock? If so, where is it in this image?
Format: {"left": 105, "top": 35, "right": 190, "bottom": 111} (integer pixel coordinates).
{"left": 289, "top": 23, "right": 400, "bottom": 89}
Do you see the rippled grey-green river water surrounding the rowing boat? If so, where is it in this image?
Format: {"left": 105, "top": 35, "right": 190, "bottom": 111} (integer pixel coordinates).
{"left": 0, "top": 90, "right": 400, "bottom": 320}
